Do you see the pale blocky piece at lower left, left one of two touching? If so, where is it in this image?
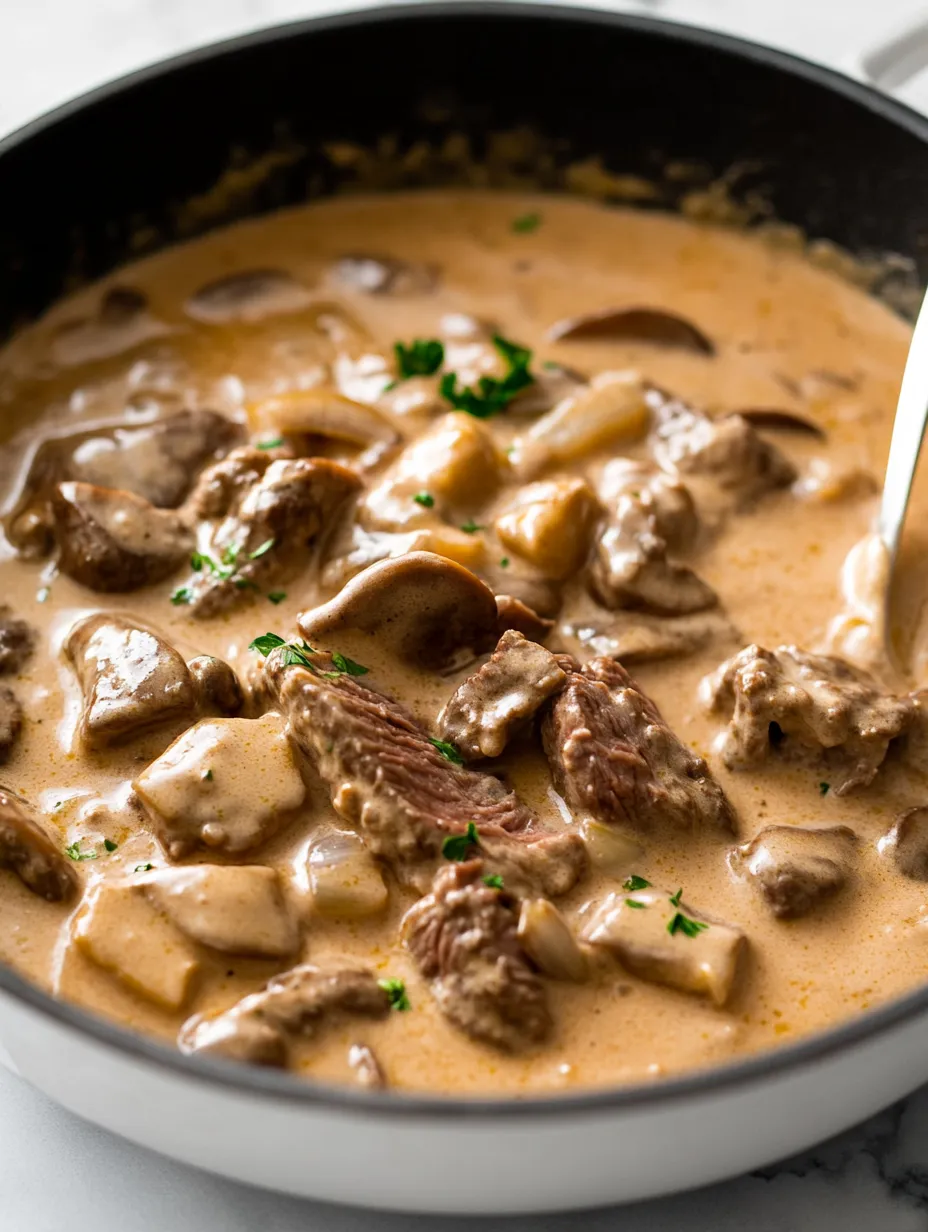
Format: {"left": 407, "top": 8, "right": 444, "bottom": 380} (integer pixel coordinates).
{"left": 71, "top": 882, "right": 200, "bottom": 1011}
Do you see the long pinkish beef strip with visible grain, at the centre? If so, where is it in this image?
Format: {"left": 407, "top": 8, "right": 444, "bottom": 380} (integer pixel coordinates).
{"left": 265, "top": 652, "right": 585, "bottom": 888}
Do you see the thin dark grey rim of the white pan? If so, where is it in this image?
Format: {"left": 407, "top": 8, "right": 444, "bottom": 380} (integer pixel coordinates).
{"left": 0, "top": 0, "right": 928, "bottom": 1120}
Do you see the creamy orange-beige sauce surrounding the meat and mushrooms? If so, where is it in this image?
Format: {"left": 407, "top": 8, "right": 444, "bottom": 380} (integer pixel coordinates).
{"left": 0, "top": 192, "right": 928, "bottom": 1094}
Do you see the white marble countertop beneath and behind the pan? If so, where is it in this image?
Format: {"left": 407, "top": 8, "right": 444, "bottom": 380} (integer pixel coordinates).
{"left": 0, "top": 0, "right": 928, "bottom": 1232}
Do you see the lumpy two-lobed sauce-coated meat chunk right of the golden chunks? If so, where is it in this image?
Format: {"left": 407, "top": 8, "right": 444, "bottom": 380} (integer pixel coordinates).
{"left": 589, "top": 460, "right": 717, "bottom": 616}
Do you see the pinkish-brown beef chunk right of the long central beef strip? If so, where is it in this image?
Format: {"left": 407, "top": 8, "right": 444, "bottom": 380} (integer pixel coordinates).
{"left": 542, "top": 658, "right": 735, "bottom": 833}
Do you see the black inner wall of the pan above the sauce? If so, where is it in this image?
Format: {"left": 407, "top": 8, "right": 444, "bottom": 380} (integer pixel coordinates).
{"left": 0, "top": 4, "right": 928, "bottom": 339}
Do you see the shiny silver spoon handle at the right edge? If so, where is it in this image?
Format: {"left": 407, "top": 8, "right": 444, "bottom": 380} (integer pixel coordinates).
{"left": 877, "top": 283, "right": 928, "bottom": 561}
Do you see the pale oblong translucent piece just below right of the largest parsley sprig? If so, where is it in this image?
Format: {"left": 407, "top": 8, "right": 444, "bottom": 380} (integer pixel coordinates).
{"left": 509, "top": 372, "right": 649, "bottom": 479}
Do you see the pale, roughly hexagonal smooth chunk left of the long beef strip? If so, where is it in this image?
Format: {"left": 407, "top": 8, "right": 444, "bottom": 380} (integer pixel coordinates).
{"left": 133, "top": 713, "right": 306, "bottom": 860}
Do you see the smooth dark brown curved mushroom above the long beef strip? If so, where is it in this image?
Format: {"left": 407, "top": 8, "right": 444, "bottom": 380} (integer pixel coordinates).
{"left": 299, "top": 552, "right": 498, "bottom": 670}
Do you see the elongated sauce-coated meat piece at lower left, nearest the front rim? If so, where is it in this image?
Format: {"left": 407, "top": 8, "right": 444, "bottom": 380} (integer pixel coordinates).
{"left": 177, "top": 966, "right": 389, "bottom": 1066}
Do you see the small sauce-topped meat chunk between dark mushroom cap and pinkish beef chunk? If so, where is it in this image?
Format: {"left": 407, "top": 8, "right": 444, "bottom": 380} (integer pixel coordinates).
{"left": 439, "top": 630, "right": 567, "bottom": 761}
